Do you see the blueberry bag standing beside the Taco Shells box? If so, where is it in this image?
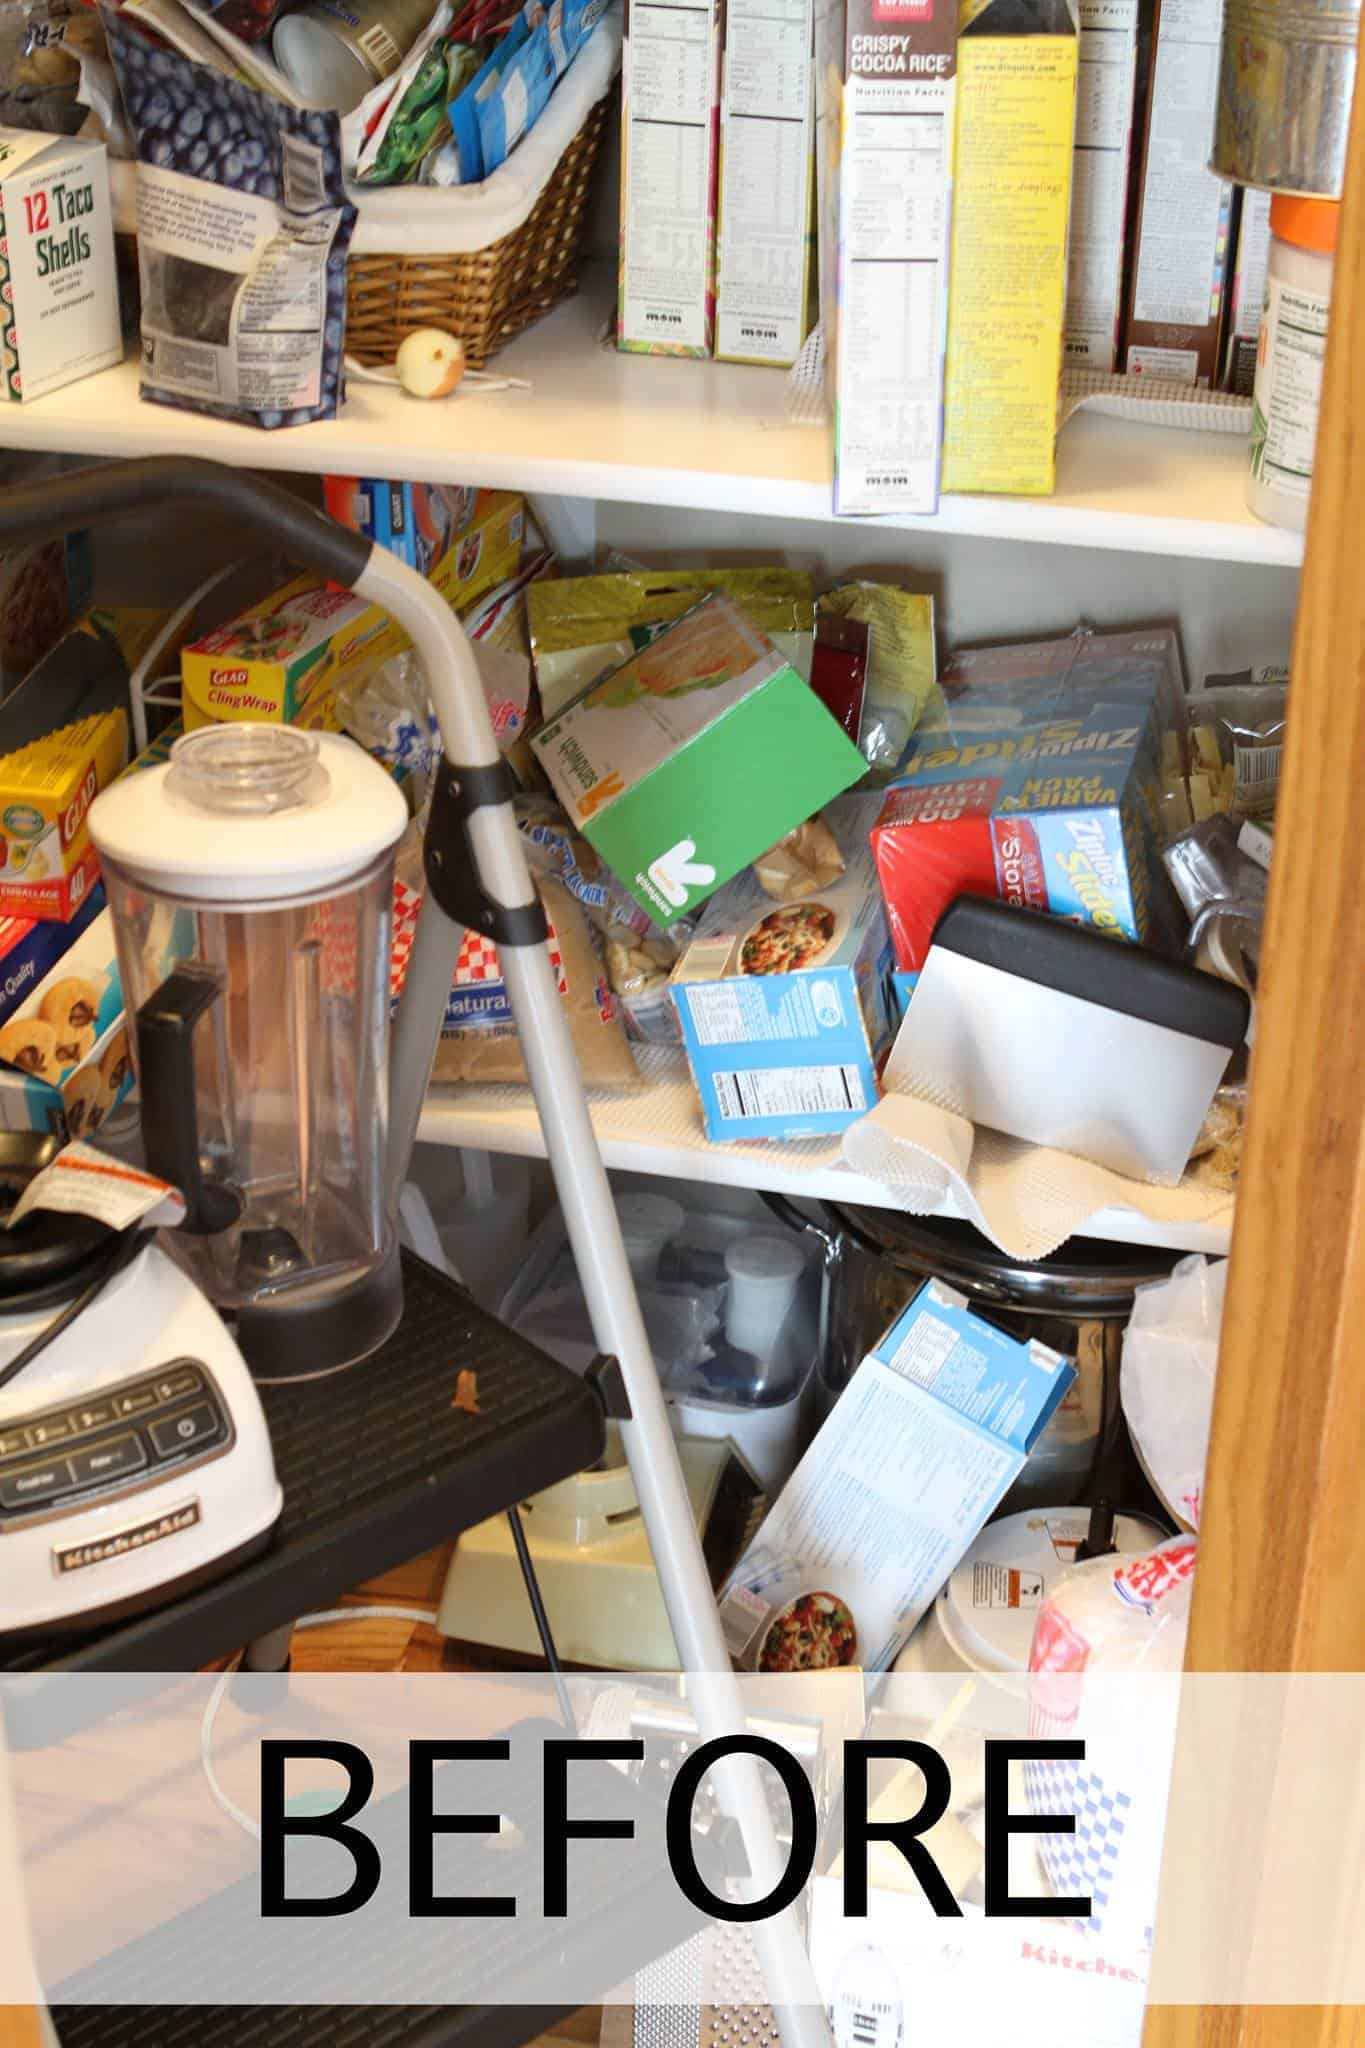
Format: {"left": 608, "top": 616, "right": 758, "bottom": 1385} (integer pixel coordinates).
{"left": 104, "top": 8, "right": 356, "bottom": 428}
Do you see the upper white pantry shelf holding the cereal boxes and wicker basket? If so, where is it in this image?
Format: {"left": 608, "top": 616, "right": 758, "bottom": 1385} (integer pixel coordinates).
{"left": 0, "top": 274, "right": 1304, "bottom": 567}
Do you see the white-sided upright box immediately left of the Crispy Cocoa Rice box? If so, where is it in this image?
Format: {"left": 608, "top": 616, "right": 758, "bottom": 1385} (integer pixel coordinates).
{"left": 716, "top": 0, "right": 814, "bottom": 369}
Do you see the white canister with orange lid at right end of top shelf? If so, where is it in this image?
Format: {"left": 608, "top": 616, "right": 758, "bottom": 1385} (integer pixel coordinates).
{"left": 1246, "top": 193, "right": 1340, "bottom": 532}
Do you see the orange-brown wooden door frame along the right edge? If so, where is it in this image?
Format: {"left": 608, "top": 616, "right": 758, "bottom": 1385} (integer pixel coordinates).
{"left": 1144, "top": 32, "right": 1365, "bottom": 2048}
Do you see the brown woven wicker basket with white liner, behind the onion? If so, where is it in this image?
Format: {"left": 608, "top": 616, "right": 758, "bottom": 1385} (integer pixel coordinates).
{"left": 346, "top": 94, "right": 610, "bottom": 369}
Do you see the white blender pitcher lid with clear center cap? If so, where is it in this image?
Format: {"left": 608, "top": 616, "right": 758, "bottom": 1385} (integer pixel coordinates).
{"left": 90, "top": 721, "right": 407, "bottom": 903}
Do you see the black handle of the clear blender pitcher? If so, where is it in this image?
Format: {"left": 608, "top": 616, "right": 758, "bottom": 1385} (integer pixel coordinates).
{"left": 137, "top": 967, "right": 241, "bottom": 1237}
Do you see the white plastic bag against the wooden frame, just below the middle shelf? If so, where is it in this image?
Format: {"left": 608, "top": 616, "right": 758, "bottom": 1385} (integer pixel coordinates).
{"left": 1119, "top": 1257, "right": 1228, "bottom": 1530}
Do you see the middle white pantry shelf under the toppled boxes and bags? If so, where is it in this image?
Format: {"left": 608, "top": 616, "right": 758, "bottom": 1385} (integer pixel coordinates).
{"left": 417, "top": 1047, "right": 1232, "bottom": 1257}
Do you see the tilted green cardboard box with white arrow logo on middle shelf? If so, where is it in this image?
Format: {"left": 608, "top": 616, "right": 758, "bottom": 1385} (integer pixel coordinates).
{"left": 532, "top": 596, "right": 868, "bottom": 926}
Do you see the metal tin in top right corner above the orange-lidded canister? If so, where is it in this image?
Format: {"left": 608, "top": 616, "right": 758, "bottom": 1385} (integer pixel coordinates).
{"left": 1212, "top": 0, "right": 1361, "bottom": 199}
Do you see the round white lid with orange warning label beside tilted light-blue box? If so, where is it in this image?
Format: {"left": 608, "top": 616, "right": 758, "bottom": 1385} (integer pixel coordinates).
{"left": 935, "top": 1507, "right": 1162, "bottom": 1671}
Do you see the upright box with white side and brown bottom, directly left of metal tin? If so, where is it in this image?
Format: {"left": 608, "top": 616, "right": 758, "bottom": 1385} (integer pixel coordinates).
{"left": 1121, "top": 0, "right": 1232, "bottom": 389}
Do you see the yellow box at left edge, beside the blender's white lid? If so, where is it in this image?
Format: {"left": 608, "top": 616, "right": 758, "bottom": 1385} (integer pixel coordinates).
{"left": 0, "top": 711, "right": 129, "bottom": 920}
